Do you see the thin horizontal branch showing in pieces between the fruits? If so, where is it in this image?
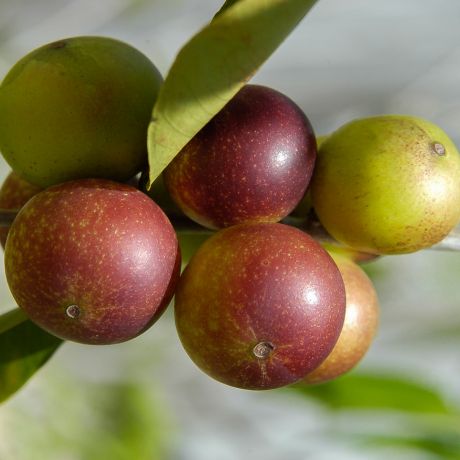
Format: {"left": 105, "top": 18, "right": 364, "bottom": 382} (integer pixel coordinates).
{"left": 0, "top": 209, "right": 460, "bottom": 251}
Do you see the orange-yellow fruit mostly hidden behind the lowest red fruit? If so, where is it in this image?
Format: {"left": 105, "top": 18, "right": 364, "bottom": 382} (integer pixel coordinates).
{"left": 303, "top": 251, "right": 380, "bottom": 384}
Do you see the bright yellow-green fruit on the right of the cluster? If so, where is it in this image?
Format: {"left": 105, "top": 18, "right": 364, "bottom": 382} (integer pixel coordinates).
{"left": 311, "top": 115, "right": 460, "bottom": 254}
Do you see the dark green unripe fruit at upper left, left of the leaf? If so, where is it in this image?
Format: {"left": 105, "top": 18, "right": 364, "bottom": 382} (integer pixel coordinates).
{"left": 0, "top": 37, "right": 162, "bottom": 187}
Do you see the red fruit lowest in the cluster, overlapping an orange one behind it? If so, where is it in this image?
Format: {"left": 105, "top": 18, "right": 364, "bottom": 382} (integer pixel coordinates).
{"left": 175, "top": 223, "right": 345, "bottom": 390}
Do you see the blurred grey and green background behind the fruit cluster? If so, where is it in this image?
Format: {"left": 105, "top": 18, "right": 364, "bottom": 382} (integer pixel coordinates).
{"left": 0, "top": 0, "right": 460, "bottom": 460}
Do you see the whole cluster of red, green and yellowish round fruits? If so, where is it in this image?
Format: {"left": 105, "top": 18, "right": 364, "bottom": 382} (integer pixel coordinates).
{"left": 0, "top": 37, "right": 460, "bottom": 389}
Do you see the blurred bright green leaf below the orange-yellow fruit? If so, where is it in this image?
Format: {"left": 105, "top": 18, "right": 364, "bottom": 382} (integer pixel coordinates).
{"left": 290, "top": 374, "right": 452, "bottom": 414}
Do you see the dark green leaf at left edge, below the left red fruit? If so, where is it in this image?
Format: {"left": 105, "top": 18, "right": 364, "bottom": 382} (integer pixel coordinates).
{"left": 0, "top": 308, "right": 62, "bottom": 402}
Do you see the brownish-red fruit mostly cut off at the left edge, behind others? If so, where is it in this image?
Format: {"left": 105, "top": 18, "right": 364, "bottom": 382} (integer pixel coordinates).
{"left": 0, "top": 171, "right": 42, "bottom": 248}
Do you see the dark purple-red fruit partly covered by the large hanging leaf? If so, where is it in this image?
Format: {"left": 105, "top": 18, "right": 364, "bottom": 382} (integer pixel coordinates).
{"left": 164, "top": 85, "right": 316, "bottom": 228}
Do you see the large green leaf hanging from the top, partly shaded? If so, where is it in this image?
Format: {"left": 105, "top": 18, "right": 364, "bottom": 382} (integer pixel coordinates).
{"left": 148, "top": 0, "right": 316, "bottom": 187}
